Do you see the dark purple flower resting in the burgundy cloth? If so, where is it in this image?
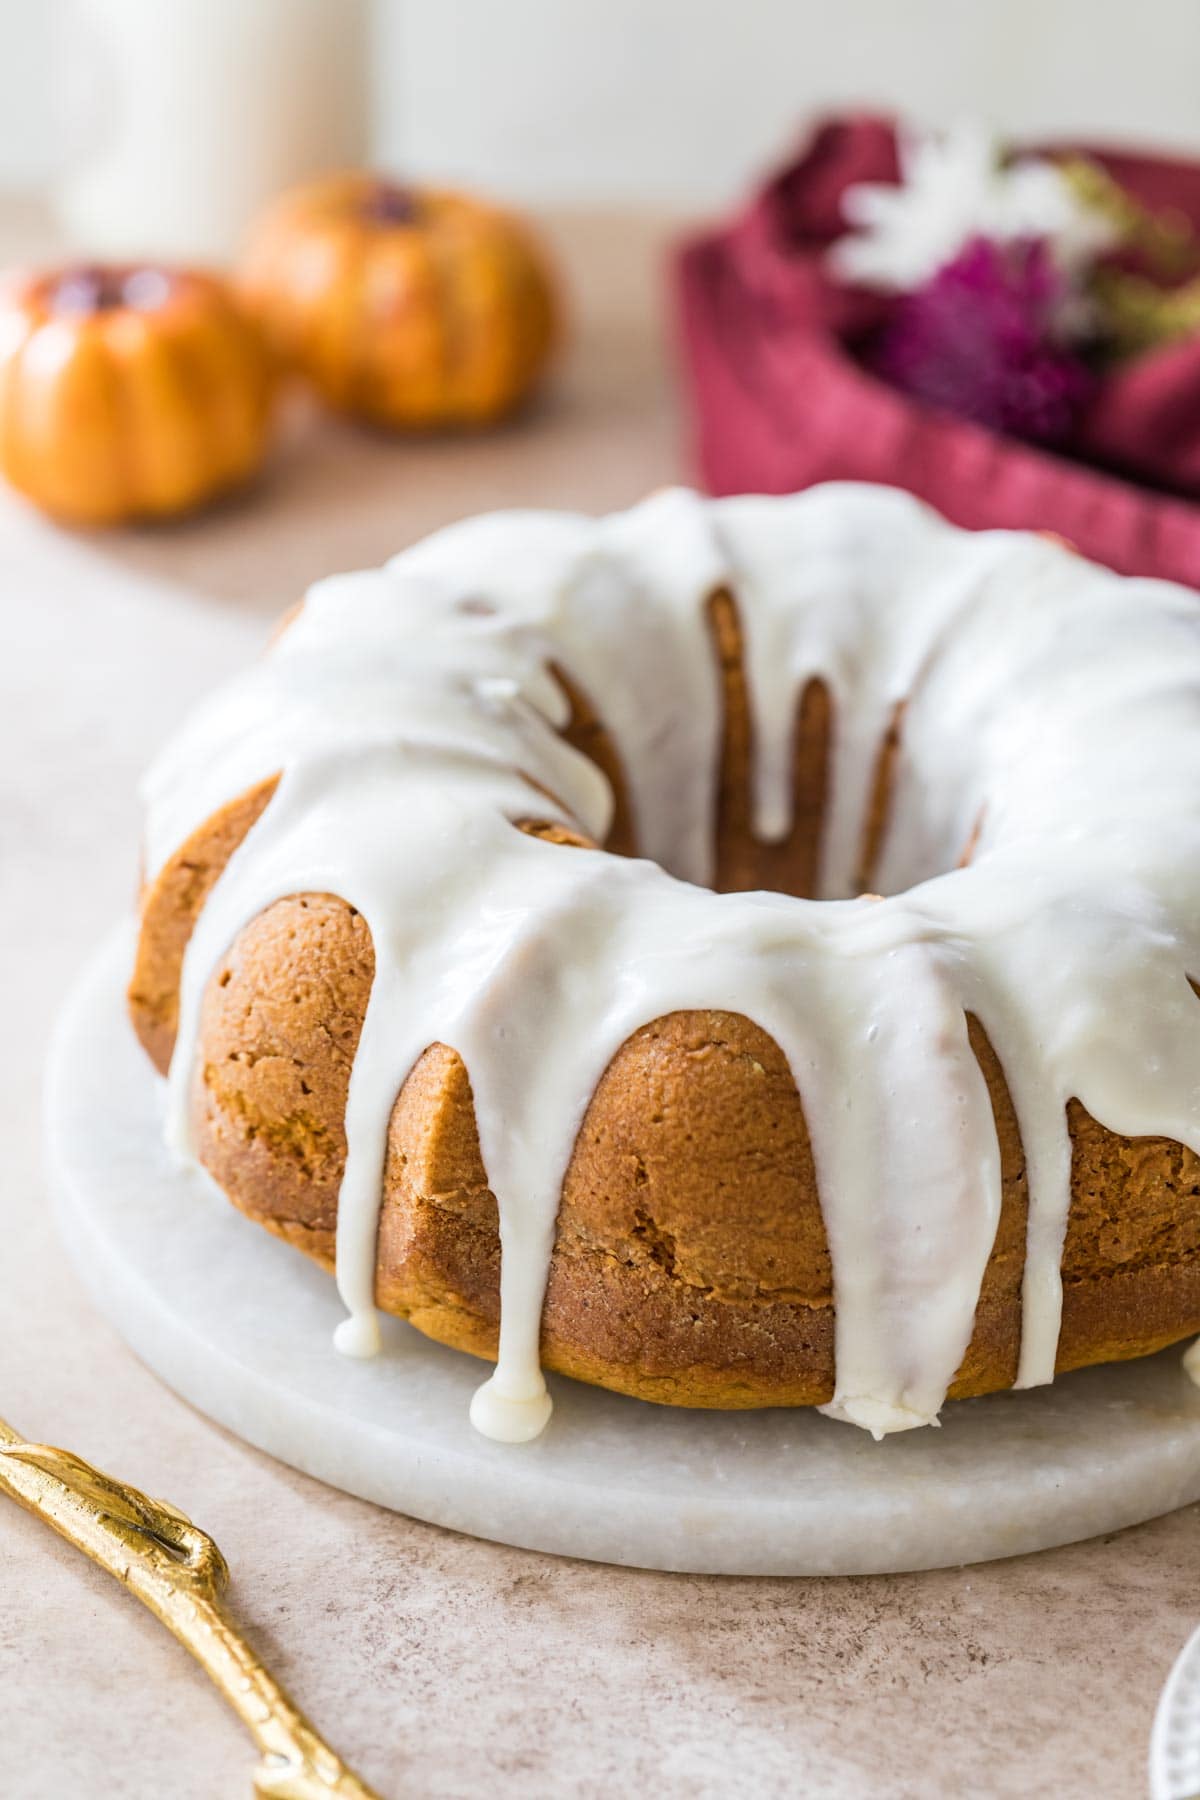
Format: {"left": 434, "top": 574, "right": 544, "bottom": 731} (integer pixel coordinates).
{"left": 873, "top": 238, "right": 1092, "bottom": 443}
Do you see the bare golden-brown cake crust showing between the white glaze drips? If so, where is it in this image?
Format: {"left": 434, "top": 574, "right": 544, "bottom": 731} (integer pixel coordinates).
{"left": 130, "top": 596, "right": 1200, "bottom": 1408}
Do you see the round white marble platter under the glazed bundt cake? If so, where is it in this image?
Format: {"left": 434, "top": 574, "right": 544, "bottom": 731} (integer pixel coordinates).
{"left": 47, "top": 931, "right": 1200, "bottom": 1575}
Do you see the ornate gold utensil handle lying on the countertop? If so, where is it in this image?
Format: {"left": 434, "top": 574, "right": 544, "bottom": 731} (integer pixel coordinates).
{"left": 0, "top": 1418, "right": 380, "bottom": 1800}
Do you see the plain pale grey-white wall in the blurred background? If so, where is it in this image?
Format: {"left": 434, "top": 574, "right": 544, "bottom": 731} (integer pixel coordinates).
{"left": 0, "top": 0, "right": 1200, "bottom": 211}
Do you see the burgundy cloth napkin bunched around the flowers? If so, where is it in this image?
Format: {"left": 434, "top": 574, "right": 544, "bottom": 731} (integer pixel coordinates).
{"left": 676, "top": 117, "right": 1200, "bottom": 587}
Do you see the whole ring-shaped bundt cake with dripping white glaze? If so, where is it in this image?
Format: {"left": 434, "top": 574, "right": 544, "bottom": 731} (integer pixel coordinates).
{"left": 130, "top": 484, "right": 1200, "bottom": 1438}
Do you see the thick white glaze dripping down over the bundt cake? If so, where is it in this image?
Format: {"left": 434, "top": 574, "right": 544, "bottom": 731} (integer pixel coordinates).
{"left": 146, "top": 484, "right": 1200, "bottom": 1440}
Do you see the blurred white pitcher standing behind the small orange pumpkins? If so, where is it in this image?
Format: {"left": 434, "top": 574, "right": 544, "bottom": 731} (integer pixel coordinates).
{"left": 54, "top": 0, "right": 371, "bottom": 263}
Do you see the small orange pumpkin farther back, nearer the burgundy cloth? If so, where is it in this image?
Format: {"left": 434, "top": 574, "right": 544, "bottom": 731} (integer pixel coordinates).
{"left": 243, "top": 173, "right": 558, "bottom": 428}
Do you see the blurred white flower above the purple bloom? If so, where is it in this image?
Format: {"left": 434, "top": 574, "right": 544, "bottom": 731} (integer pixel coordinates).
{"left": 829, "top": 124, "right": 1117, "bottom": 293}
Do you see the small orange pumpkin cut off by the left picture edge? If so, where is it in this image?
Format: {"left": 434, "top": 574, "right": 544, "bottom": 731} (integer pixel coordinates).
{"left": 0, "top": 266, "right": 273, "bottom": 526}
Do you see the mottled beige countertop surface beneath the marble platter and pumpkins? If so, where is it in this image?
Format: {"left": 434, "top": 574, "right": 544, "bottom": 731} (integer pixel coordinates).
{"left": 0, "top": 204, "right": 1200, "bottom": 1800}
